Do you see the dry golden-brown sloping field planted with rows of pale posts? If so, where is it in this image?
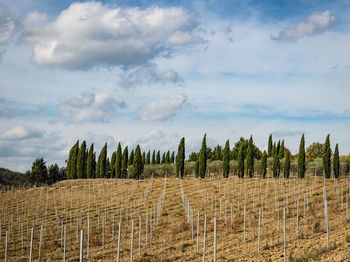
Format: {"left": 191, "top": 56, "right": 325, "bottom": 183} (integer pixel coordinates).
{"left": 0, "top": 176, "right": 350, "bottom": 261}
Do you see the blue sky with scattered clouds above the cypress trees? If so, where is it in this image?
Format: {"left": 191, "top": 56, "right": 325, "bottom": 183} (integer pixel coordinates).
{"left": 0, "top": 0, "right": 350, "bottom": 171}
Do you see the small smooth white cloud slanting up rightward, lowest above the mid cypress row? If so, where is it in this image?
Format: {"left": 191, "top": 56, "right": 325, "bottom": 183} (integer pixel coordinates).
{"left": 138, "top": 95, "right": 187, "bottom": 121}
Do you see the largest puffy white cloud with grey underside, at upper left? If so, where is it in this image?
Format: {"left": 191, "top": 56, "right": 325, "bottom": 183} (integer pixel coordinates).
{"left": 24, "top": 2, "right": 201, "bottom": 69}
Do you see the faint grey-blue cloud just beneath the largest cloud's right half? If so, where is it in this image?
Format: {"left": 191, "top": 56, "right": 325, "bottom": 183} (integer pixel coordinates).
{"left": 120, "top": 64, "right": 184, "bottom": 88}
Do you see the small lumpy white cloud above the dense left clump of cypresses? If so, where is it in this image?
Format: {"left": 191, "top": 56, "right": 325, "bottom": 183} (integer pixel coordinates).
{"left": 58, "top": 93, "right": 126, "bottom": 123}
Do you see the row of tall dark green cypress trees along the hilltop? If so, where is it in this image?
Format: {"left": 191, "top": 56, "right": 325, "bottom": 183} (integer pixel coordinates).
{"left": 65, "top": 134, "right": 340, "bottom": 179}
